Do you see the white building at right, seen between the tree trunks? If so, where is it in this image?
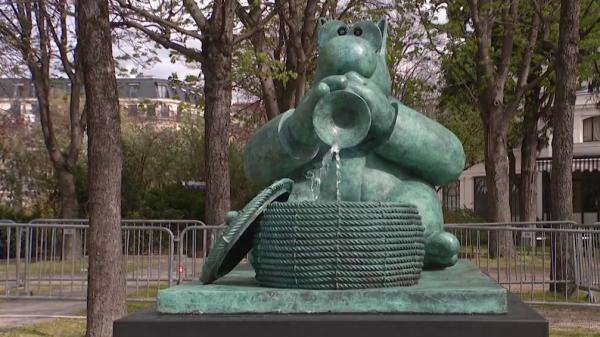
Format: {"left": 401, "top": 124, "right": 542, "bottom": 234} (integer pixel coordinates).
{"left": 442, "top": 85, "right": 600, "bottom": 223}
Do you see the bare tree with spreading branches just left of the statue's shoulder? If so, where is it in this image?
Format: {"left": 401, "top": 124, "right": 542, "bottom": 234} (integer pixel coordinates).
{"left": 115, "top": 0, "right": 271, "bottom": 230}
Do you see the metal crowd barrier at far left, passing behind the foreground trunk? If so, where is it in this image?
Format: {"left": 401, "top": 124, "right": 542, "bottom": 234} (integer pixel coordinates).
{"left": 0, "top": 221, "right": 175, "bottom": 300}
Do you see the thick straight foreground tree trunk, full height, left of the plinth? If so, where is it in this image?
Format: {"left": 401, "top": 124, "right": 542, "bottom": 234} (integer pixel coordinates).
{"left": 76, "top": 0, "right": 126, "bottom": 337}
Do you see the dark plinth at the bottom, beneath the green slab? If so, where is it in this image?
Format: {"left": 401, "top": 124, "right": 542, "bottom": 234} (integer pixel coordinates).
{"left": 113, "top": 295, "right": 548, "bottom": 337}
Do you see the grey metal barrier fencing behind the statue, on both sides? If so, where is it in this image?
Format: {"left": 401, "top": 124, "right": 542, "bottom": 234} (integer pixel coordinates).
{"left": 0, "top": 219, "right": 600, "bottom": 305}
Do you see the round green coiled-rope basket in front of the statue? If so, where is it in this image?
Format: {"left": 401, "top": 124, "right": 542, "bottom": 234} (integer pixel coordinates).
{"left": 252, "top": 201, "right": 425, "bottom": 289}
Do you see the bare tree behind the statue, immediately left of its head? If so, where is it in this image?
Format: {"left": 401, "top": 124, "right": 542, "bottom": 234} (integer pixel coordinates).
{"left": 236, "top": 0, "right": 364, "bottom": 119}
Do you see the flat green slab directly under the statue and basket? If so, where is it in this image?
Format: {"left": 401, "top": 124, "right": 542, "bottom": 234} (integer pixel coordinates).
{"left": 157, "top": 261, "right": 507, "bottom": 314}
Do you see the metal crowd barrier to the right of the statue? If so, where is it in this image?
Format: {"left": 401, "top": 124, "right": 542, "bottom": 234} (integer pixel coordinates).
{"left": 445, "top": 221, "right": 600, "bottom": 306}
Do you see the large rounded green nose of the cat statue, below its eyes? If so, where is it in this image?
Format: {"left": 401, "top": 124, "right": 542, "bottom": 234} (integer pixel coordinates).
{"left": 318, "top": 36, "right": 377, "bottom": 78}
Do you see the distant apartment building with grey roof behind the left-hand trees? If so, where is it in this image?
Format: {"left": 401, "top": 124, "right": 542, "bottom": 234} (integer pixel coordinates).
{"left": 0, "top": 77, "right": 198, "bottom": 123}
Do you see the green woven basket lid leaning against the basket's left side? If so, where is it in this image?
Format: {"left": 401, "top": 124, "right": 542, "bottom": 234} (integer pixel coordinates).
{"left": 200, "top": 178, "right": 294, "bottom": 284}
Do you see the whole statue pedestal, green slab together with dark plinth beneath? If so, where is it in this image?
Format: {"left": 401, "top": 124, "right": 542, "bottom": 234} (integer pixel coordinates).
{"left": 113, "top": 261, "right": 548, "bottom": 337}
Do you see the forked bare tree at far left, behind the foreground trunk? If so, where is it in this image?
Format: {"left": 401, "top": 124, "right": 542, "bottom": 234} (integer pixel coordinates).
{"left": 0, "top": 0, "right": 85, "bottom": 218}
